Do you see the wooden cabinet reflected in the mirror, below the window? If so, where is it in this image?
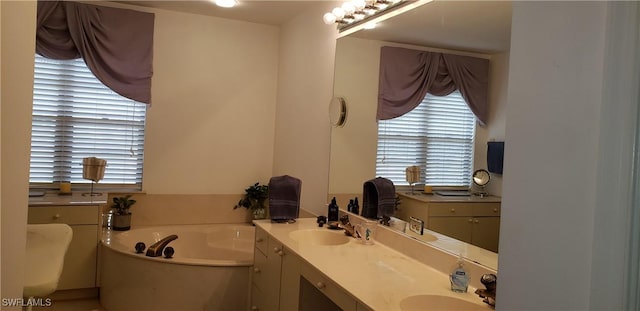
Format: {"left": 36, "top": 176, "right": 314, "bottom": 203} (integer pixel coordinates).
{"left": 396, "top": 196, "right": 500, "bottom": 252}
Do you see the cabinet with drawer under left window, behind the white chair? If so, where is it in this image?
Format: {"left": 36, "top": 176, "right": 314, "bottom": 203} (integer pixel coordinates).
{"left": 28, "top": 205, "right": 100, "bottom": 290}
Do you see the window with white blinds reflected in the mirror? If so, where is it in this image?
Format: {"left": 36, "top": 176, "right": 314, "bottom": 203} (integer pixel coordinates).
{"left": 376, "top": 91, "right": 476, "bottom": 186}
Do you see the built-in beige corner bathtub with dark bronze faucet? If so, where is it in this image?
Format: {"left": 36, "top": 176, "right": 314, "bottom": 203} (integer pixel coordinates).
{"left": 99, "top": 224, "right": 255, "bottom": 311}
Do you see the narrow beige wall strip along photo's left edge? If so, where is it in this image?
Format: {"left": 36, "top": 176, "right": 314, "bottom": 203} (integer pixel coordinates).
{"left": 0, "top": 1, "right": 36, "bottom": 310}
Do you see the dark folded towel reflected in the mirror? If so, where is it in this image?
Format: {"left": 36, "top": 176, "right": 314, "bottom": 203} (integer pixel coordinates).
{"left": 362, "top": 177, "right": 396, "bottom": 219}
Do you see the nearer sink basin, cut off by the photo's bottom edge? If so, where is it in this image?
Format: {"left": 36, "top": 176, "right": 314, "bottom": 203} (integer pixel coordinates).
{"left": 400, "top": 295, "right": 491, "bottom": 311}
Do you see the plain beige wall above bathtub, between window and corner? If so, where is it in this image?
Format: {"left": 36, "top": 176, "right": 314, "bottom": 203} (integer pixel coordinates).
{"left": 131, "top": 6, "right": 278, "bottom": 194}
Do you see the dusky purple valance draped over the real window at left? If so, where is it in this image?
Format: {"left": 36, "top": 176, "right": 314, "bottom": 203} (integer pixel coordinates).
{"left": 36, "top": 0, "right": 154, "bottom": 103}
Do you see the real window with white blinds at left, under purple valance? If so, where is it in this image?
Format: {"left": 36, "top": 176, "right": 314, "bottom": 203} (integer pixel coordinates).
{"left": 29, "top": 55, "right": 146, "bottom": 189}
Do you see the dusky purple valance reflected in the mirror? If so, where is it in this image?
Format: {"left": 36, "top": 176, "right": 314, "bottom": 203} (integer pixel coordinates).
{"left": 377, "top": 46, "right": 489, "bottom": 124}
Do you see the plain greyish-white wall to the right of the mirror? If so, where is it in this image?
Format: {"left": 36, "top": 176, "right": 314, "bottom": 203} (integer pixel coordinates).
{"left": 497, "top": 1, "right": 618, "bottom": 310}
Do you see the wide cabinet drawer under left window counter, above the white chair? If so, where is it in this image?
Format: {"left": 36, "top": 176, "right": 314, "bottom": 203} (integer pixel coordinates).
{"left": 28, "top": 205, "right": 99, "bottom": 225}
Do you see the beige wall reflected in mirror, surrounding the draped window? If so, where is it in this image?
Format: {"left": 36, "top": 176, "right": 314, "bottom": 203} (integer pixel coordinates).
{"left": 329, "top": 37, "right": 509, "bottom": 195}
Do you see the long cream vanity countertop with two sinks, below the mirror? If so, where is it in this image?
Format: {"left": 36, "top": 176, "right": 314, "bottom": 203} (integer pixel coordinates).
{"left": 254, "top": 218, "right": 491, "bottom": 310}
